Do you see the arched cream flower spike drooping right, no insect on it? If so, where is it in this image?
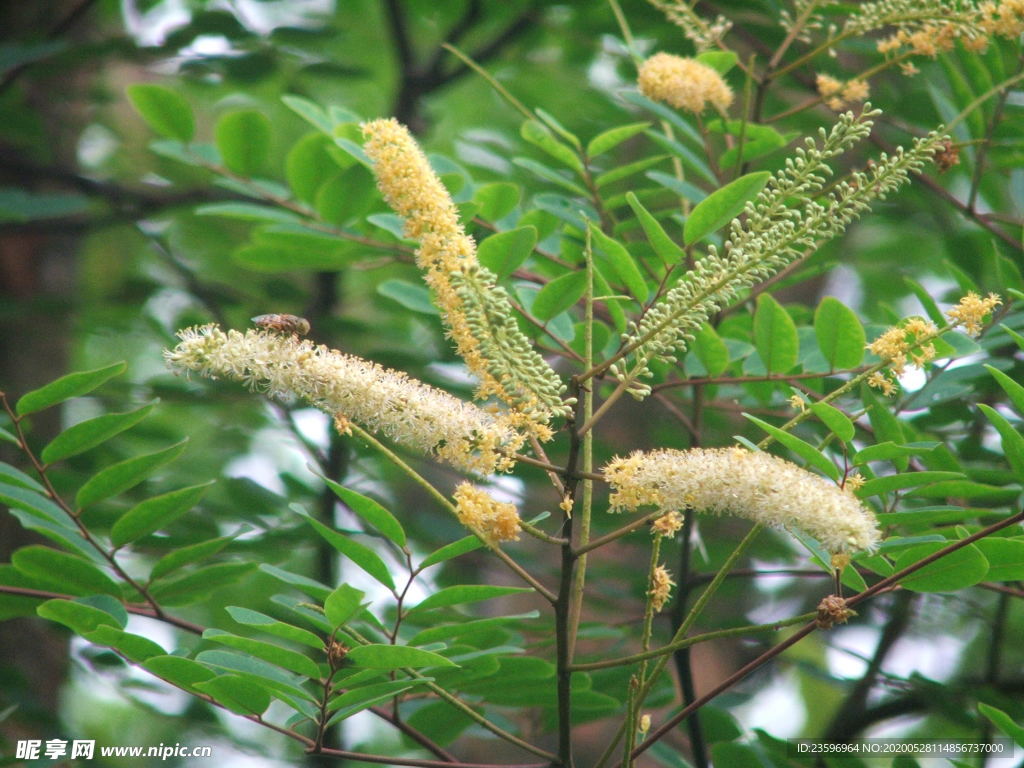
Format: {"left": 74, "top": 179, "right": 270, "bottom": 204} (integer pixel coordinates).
{"left": 604, "top": 447, "right": 879, "bottom": 552}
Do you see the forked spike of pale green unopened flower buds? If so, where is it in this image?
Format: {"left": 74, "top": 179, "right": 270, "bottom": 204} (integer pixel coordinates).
{"left": 609, "top": 104, "right": 943, "bottom": 398}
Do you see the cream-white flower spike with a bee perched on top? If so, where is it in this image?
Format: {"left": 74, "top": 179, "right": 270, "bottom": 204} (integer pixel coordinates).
{"left": 164, "top": 325, "right": 524, "bottom": 474}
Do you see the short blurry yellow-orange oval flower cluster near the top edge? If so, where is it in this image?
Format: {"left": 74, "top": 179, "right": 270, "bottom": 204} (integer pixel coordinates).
{"left": 637, "top": 53, "right": 732, "bottom": 115}
